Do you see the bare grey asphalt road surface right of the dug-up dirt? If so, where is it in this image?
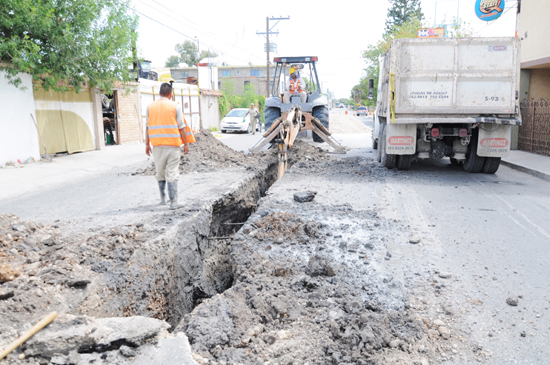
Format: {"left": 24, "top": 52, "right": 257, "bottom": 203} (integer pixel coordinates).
{"left": 223, "top": 125, "right": 550, "bottom": 364}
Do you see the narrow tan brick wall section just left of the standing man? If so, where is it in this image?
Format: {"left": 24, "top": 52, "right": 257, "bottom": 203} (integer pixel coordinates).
{"left": 117, "top": 86, "right": 142, "bottom": 144}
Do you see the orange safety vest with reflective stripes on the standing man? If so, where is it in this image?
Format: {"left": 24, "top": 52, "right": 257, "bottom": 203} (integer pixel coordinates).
{"left": 147, "top": 99, "right": 183, "bottom": 147}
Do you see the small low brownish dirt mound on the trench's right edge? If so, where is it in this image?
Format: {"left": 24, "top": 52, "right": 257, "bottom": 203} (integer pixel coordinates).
{"left": 251, "top": 212, "right": 320, "bottom": 244}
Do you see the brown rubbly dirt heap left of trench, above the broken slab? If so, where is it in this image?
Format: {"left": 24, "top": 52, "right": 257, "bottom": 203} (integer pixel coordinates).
{"left": 0, "top": 214, "right": 165, "bottom": 362}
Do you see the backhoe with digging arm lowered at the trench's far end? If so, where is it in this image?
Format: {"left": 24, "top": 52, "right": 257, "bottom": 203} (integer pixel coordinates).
{"left": 250, "top": 56, "right": 345, "bottom": 178}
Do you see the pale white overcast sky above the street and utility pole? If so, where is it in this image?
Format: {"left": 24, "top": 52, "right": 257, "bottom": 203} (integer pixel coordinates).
{"left": 131, "top": 0, "right": 516, "bottom": 98}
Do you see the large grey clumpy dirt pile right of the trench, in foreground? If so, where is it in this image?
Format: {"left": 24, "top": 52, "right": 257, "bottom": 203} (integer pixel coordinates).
{"left": 176, "top": 205, "right": 428, "bottom": 364}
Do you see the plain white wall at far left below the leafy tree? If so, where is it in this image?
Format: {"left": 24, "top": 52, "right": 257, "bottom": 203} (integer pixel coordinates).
{"left": 0, "top": 71, "right": 40, "bottom": 166}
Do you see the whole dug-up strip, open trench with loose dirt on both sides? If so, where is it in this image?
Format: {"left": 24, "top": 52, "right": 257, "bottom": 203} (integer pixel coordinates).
{"left": 0, "top": 138, "right": 476, "bottom": 364}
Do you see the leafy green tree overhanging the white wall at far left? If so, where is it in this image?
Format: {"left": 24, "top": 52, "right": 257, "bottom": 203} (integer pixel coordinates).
{"left": 0, "top": 0, "right": 138, "bottom": 91}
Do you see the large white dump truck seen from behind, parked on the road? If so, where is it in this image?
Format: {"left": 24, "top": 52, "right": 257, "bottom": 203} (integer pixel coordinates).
{"left": 369, "top": 37, "right": 521, "bottom": 174}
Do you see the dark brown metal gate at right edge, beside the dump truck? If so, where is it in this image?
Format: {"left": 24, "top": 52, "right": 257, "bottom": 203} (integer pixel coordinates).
{"left": 519, "top": 99, "right": 550, "bottom": 156}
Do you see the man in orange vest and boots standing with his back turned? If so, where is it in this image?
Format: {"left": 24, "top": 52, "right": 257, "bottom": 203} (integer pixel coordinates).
{"left": 145, "top": 83, "right": 193, "bottom": 210}
